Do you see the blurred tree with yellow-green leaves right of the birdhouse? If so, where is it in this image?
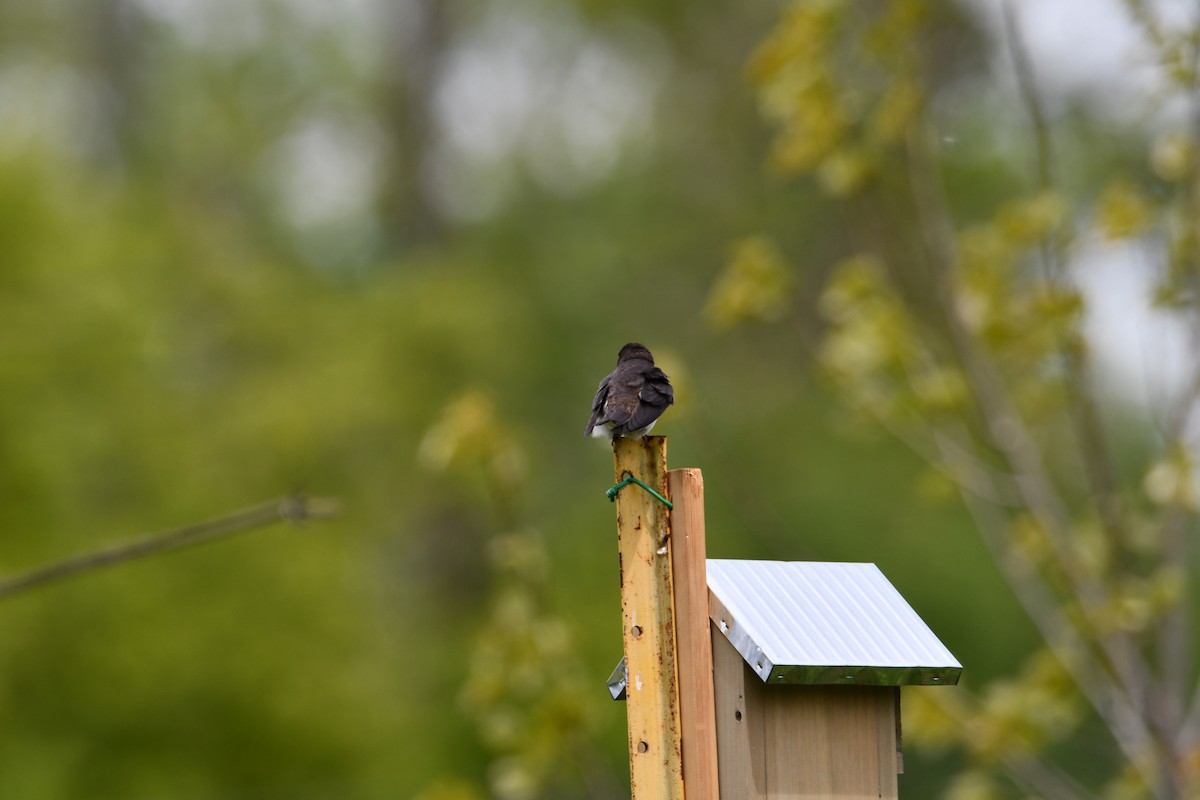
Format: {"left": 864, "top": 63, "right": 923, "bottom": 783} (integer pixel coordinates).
{"left": 709, "top": 0, "right": 1200, "bottom": 799}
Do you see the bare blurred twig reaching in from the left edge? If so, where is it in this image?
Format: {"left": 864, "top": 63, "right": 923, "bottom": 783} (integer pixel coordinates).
{"left": 0, "top": 497, "right": 338, "bottom": 600}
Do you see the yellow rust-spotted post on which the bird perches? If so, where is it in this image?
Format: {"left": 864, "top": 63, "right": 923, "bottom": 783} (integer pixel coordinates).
{"left": 613, "top": 437, "right": 684, "bottom": 800}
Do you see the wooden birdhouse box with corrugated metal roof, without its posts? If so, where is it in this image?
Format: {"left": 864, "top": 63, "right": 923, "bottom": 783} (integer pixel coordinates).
{"left": 707, "top": 559, "right": 962, "bottom": 800}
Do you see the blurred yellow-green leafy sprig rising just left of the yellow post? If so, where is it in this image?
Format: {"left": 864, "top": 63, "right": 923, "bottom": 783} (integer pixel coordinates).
{"left": 420, "top": 390, "right": 589, "bottom": 800}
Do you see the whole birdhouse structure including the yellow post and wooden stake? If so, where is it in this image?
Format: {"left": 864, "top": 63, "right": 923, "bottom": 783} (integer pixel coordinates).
{"left": 607, "top": 437, "right": 962, "bottom": 800}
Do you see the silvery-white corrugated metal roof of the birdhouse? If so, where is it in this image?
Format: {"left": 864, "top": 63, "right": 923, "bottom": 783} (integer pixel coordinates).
{"left": 708, "top": 559, "right": 962, "bottom": 686}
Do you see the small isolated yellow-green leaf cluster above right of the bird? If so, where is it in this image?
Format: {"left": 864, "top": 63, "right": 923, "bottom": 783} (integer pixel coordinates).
{"left": 704, "top": 236, "right": 792, "bottom": 327}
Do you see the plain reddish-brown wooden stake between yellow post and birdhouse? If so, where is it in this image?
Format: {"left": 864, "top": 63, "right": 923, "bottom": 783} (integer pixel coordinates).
{"left": 667, "top": 469, "right": 732, "bottom": 800}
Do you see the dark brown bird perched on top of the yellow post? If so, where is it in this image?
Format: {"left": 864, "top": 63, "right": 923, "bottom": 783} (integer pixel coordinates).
{"left": 583, "top": 342, "right": 674, "bottom": 439}
